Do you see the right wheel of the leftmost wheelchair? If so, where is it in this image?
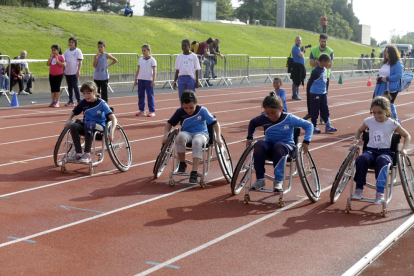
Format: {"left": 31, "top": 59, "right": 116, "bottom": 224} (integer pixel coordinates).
{"left": 105, "top": 122, "right": 132, "bottom": 172}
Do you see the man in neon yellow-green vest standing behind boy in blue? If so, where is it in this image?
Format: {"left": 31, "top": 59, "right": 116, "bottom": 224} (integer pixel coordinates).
{"left": 303, "top": 34, "right": 334, "bottom": 120}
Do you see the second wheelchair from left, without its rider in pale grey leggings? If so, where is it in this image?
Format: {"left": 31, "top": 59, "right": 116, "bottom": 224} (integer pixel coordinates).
{"left": 153, "top": 125, "right": 233, "bottom": 188}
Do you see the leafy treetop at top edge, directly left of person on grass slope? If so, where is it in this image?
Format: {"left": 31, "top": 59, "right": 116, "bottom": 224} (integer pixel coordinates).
{"left": 68, "top": 0, "right": 125, "bottom": 13}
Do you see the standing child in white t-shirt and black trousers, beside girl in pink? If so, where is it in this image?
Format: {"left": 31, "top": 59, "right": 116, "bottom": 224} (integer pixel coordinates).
{"left": 63, "top": 37, "right": 83, "bottom": 106}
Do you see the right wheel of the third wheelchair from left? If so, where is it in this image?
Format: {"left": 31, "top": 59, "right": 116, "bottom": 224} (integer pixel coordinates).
{"left": 296, "top": 144, "right": 321, "bottom": 202}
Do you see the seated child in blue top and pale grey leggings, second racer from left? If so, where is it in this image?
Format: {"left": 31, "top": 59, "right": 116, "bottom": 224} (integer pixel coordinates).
{"left": 162, "top": 90, "right": 223, "bottom": 183}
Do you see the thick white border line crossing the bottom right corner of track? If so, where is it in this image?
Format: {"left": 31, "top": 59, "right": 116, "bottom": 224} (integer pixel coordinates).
{"left": 342, "top": 215, "right": 414, "bottom": 276}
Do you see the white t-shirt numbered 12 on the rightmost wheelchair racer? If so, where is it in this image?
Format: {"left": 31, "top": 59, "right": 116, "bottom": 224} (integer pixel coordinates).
{"left": 364, "top": 116, "right": 400, "bottom": 149}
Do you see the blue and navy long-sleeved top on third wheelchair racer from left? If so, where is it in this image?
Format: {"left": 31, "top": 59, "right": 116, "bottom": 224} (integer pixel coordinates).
{"left": 247, "top": 112, "right": 313, "bottom": 145}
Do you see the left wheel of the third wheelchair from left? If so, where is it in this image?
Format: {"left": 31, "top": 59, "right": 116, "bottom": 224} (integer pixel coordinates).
{"left": 231, "top": 142, "right": 256, "bottom": 195}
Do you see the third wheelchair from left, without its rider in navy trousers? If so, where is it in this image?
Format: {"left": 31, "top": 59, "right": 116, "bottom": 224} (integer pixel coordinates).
{"left": 231, "top": 128, "right": 321, "bottom": 207}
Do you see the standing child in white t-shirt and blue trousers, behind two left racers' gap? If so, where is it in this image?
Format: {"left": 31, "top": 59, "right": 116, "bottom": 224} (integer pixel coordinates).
{"left": 134, "top": 44, "right": 157, "bottom": 117}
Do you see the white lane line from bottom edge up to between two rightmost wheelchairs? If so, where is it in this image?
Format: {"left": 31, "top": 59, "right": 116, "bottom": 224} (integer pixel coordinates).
{"left": 136, "top": 186, "right": 331, "bottom": 276}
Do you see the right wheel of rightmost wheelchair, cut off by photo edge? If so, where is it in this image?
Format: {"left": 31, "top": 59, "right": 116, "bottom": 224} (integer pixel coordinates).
{"left": 397, "top": 154, "right": 414, "bottom": 211}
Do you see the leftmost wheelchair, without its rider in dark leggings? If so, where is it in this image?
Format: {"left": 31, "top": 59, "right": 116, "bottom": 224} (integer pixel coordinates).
{"left": 53, "top": 119, "right": 132, "bottom": 175}
